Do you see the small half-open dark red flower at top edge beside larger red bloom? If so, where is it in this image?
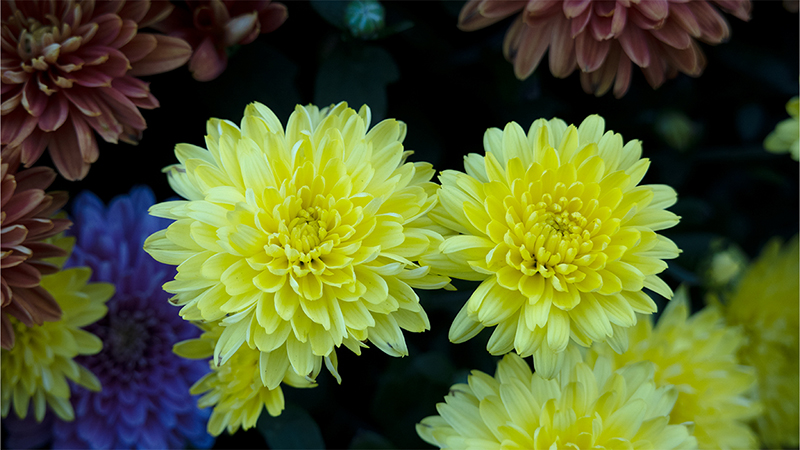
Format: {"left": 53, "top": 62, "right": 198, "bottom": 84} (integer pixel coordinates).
{"left": 154, "top": 0, "right": 288, "bottom": 81}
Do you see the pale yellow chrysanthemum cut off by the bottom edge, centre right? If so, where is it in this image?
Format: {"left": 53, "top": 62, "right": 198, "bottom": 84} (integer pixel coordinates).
{"left": 417, "top": 353, "right": 697, "bottom": 450}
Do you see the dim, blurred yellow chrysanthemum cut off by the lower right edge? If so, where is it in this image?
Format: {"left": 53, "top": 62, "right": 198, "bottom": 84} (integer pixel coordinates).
{"left": 724, "top": 236, "right": 800, "bottom": 448}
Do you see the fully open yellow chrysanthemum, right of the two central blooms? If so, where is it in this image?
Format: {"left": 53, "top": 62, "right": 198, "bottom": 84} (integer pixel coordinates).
{"left": 422, "top": 116, "right": 680, "bottom": 377}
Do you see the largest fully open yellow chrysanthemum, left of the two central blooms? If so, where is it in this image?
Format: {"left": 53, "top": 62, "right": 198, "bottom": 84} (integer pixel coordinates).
{"left": 145, "top": 103, "right": 449, "bottom": 384}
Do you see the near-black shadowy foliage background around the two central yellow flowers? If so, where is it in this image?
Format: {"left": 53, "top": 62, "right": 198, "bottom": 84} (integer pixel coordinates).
{"left": 40, "top": 1, "right": 798, "bottom": 448}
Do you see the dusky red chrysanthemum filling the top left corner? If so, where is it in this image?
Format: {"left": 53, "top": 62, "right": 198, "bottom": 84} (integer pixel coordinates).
{"left": 0, "top": 0, "right": 191, "bottom": 180}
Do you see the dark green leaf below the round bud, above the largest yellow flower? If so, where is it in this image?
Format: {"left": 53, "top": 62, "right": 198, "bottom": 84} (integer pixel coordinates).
{"left": 314, "top": 42, "right": 399, "bottom": 123}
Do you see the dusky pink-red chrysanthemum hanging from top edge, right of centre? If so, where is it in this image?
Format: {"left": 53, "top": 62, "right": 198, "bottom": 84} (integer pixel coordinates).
{"left": 458, "top": 0, "right": 751, "bottom": 98}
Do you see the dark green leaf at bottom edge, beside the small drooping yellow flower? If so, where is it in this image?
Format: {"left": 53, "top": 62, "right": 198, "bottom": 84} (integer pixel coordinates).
{"left": 256, "top": 405, "right": 325, "bottom": 449}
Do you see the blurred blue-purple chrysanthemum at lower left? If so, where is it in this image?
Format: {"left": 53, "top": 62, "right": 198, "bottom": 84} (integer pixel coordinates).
{"left": 53, "top": 187, "right": 214, "bottom": 449}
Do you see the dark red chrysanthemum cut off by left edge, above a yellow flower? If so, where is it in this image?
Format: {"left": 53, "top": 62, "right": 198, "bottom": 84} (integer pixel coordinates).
{"left": 0, "top": 149, "right": 72, "bottom": 349}
